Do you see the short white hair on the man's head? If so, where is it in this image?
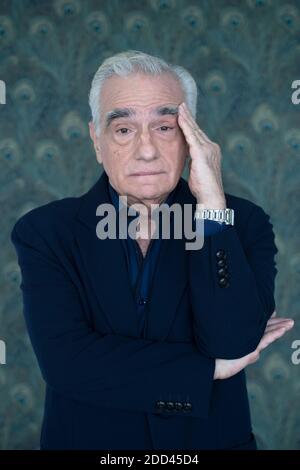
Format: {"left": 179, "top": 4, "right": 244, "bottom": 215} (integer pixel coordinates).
{"left": 89, "top": 50, "right": 197, "bottom": 137}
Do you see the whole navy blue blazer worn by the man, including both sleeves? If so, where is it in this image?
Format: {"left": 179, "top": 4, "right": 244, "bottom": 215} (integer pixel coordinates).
{"left": 11, "top": 172, "right": 278, "bottom": 450}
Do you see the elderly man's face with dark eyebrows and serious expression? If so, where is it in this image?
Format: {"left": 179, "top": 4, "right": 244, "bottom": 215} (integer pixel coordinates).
{"left": 90, "top": 74, "right": 188, "bottom": 205}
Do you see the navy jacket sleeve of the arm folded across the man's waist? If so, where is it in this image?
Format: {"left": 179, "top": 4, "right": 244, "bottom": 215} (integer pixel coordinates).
{"left": 11, "top": 215, "right": 215, "bottom": 418}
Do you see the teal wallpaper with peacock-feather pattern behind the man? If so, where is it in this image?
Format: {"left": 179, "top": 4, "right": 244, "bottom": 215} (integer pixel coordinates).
{"left": 0, "top": 0, "right": 300, "bottom": 449}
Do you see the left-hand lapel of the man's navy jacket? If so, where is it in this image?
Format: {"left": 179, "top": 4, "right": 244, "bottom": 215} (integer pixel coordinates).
{"left": 76, "top": 172, "right": 138, "bottom": 337}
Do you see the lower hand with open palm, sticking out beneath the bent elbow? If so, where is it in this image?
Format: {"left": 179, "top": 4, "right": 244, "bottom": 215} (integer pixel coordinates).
{"left": 214, "top": 312, "right": 294, "bottom": 379}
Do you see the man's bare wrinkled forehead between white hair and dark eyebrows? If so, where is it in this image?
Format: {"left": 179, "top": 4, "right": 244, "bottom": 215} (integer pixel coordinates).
{"left": 101, "top": 73, "right": 184, "bottom": 115}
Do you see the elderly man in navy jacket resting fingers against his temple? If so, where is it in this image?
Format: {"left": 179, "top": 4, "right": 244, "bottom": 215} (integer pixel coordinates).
{"left": 12, "top": 51, "right": 293, "bottom": 450}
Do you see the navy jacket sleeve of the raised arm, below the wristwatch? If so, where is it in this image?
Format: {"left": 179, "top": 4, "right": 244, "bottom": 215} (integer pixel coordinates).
{"left": 188, "top": 204, "right": 278, "bottom": 359}
